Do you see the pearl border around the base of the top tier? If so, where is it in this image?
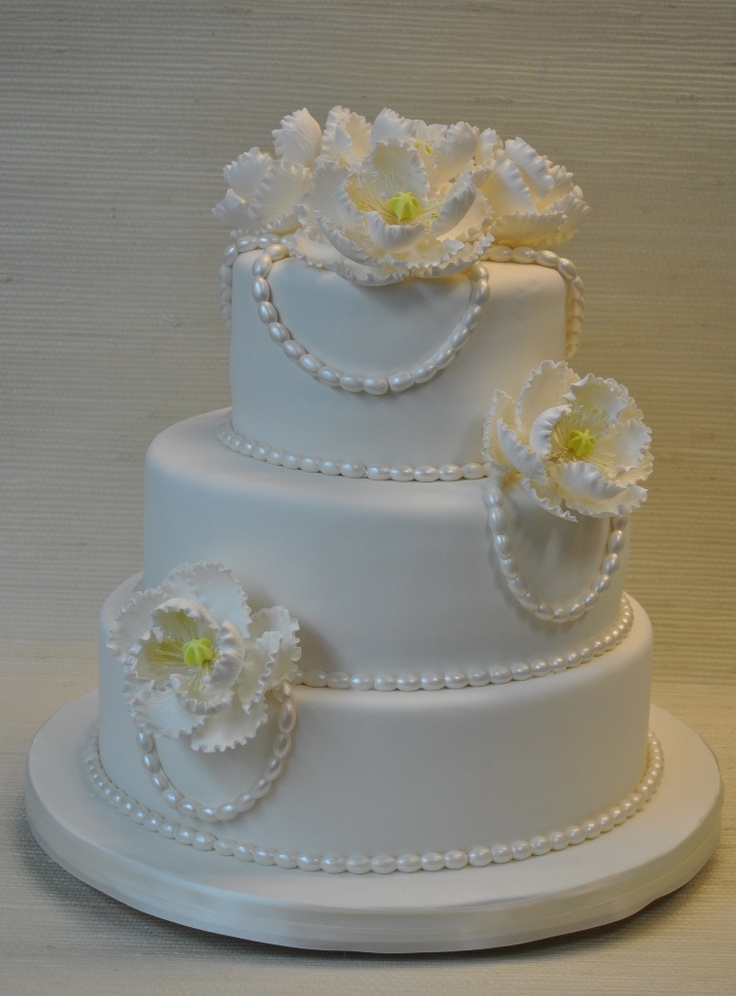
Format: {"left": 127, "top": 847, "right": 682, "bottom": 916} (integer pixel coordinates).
{"left": 217, "top": 416, "right": 487, "bottom": 483}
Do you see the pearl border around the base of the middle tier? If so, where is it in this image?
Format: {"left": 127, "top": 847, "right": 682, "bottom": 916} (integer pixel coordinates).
{"left": 294, "top": 595, "right": 634, "bottom": 692}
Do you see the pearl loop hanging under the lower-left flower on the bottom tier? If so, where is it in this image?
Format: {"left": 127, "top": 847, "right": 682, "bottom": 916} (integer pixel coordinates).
{"left": 136, "top": 682, "right": 296, "bottom": 823}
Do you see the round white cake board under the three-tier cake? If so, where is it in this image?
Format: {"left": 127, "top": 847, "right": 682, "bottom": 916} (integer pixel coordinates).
{"left": 26, "top": 693, "right": 723, "bottom": 953}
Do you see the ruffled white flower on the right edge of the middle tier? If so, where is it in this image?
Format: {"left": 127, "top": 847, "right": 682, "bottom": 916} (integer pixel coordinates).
{"left": 483, "top": 361, "right": 652, "bottom": 520}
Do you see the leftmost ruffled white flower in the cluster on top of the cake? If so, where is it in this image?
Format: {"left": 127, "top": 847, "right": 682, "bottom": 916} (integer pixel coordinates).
{"left": 214, "top": 108, "right": 322, "bottom": 235}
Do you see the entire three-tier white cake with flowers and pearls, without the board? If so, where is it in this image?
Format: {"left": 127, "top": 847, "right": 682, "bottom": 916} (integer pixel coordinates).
{"left": 87, "top": 108, "right": 662, "bottom": 875}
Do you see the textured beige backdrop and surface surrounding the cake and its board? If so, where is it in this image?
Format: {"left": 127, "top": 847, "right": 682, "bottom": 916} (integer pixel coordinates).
{"left": 0, "top": 0, "right": 736, "bottom": 993}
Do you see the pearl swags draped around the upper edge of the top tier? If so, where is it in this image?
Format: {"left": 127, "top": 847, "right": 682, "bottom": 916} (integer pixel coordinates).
{"left": 220, "top": 235, "right": 583, "bottom": 366}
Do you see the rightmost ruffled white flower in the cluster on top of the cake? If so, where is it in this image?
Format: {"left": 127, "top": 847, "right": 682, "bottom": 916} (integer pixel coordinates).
{"left": 476, "top": 129, "right": 590, "bottom": 249}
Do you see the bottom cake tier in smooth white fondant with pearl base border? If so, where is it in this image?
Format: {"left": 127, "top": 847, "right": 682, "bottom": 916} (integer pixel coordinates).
{"left": 98, "top": 579, "right": 661, "bottom": 871}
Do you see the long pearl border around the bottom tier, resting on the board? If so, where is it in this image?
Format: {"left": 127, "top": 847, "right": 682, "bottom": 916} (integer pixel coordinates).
{"left": 84, "top": 729, "right": 664, "bottom": 875}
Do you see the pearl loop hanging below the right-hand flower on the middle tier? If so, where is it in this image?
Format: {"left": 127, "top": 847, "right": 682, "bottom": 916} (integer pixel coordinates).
{"left": 485, "top": 478, "right": 628, "bottom": 623}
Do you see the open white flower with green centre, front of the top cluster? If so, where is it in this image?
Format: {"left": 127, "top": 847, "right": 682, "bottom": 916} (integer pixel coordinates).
{"left": 287, "top": 108, "right": 492, "bottom": 284}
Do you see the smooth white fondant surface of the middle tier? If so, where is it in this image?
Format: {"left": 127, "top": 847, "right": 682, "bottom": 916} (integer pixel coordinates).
{"left": 143, "top": 413, "right": 625, "bottom": 676}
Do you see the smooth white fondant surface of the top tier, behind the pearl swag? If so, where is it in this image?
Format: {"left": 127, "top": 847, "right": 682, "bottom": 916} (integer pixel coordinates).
{"left": 230, "top": 252, "right": 567, "bottom": 467}
